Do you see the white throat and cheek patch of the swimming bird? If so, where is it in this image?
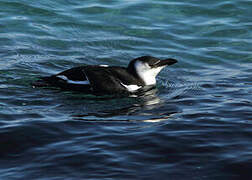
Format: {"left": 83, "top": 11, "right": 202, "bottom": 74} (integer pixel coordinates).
{"left": 135, "top": 61, "right": 165, "bottom": 86}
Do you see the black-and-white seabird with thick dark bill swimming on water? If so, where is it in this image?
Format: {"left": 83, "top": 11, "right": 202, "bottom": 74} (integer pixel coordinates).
{"left": 32, "top": 56, "right": 177, "bottom": 95}
